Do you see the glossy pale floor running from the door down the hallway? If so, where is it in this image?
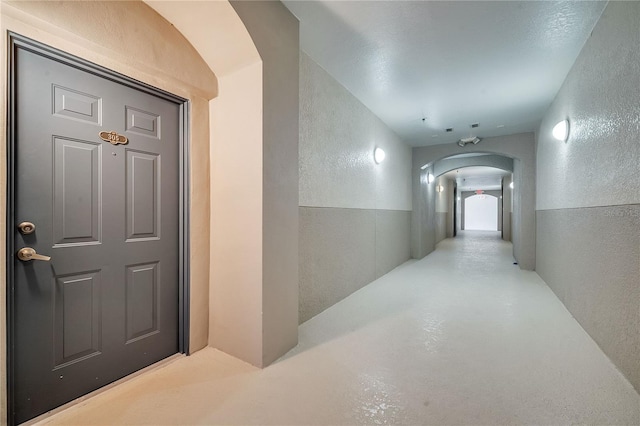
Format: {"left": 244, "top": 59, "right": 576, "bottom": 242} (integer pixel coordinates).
{"left": 36, "top": 231, "right": 640, "bottom": 425}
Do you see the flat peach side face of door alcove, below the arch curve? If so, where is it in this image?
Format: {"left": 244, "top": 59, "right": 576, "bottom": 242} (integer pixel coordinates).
{"left": 209, "top": 63, "right": 262, "bottom": 365}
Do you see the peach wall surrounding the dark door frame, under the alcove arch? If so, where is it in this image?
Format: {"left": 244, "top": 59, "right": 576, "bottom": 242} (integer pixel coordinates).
{"left": 0, "top": 1, "right": 228, "bottom": 421}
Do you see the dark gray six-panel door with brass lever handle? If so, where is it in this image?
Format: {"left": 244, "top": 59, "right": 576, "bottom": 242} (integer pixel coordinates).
{"left": 10, "top": 38, "right": 181, "bottom": 423}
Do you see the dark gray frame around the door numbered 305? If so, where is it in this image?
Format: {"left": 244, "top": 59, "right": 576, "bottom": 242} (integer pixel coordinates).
{"left": 5, "top": 32, "right": 190, "bottom": 424}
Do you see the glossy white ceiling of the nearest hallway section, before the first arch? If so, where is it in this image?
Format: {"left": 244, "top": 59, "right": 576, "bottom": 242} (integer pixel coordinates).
{"left": 283, "top": 0, "right": 606, "bottom": 146}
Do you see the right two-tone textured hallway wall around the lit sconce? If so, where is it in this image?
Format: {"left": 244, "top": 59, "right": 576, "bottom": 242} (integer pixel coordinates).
{"left": 536, "top": 2, "right": 640, "bottom": 391}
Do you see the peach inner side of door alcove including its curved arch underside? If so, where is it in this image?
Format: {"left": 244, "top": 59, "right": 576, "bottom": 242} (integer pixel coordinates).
{"left": 146, "top": 0, "right": 278, "bottom": 366}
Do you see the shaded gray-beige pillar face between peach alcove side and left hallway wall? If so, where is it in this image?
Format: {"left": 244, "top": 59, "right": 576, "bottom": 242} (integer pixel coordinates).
{"left": 231, "top": 0, "right": 300, "bottom": 366}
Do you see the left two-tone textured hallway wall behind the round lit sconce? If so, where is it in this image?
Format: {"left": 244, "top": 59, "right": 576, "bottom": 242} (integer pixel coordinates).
{"left": 299, "top": 52, "right": 411, "bottom": 323}
